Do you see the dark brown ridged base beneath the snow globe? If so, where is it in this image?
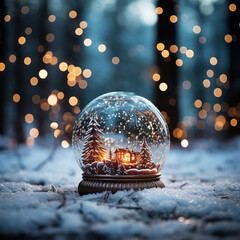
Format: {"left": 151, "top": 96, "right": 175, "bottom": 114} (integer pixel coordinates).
{"left": 78, "top": 174, "right": 165, "bottom": 195}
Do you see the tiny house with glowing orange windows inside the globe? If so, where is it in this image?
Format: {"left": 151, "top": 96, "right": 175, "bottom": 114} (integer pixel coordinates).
{"left": 114, "top": 147, "right": 140, "bottom": 163}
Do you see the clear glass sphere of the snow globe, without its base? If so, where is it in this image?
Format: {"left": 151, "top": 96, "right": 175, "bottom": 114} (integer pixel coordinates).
{"left": 72, "top": 92, "right": 170, "bottom": 175}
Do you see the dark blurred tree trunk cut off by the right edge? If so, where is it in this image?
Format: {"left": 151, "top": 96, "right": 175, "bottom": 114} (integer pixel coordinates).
{"left": 227, "top": 0, "right": 240, "bottom": 137}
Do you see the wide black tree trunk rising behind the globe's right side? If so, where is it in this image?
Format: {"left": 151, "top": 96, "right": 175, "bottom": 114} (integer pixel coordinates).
{"left": 155, "top": 0, "right": 178, "bottom": 140}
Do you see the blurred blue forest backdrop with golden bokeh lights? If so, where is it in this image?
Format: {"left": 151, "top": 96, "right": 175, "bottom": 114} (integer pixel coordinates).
{"left": 0, "top": 0, "right": 240, "bottom": 148}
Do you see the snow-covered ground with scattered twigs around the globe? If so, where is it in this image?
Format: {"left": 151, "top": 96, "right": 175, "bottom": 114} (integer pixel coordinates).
{"left": 0, "top": 138, "right": 240, "bottom": 240}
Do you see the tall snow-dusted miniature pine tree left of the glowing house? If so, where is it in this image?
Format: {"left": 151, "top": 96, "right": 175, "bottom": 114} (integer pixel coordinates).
{"left": 82, "top": 116, "right": 106, "bottom": 165}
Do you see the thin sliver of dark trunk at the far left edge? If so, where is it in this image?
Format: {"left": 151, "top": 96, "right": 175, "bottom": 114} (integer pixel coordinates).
{"left": 0, "top": 1, "right": 6, "bottom": 135}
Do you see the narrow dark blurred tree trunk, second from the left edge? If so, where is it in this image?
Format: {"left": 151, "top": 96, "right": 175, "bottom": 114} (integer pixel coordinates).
{"left": 14, "top": 1, "right": 25, "bottom": 143}
